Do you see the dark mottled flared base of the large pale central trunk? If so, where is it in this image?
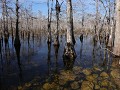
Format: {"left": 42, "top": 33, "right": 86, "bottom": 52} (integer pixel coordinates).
{"left": 63, "top": 43, "right": 77, "bottom": 60}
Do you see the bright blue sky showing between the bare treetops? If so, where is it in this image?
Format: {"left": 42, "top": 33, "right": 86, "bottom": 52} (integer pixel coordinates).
{"left": 0, "top": 0, "right": 100, "bottom": 15}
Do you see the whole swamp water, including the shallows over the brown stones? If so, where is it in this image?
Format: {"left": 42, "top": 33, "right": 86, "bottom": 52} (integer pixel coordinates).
{"left": 0, "top": 33, "right": 117, "bottom": 90}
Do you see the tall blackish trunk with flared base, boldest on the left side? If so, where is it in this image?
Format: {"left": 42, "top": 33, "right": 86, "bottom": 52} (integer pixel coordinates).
{"left": 14, "top": 0, "right": 20, "bottom": 47}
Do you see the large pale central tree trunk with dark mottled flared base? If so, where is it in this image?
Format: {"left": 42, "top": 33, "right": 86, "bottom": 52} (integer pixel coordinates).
{"left": 63, "top": 0, "right": 76, "bottom": 59}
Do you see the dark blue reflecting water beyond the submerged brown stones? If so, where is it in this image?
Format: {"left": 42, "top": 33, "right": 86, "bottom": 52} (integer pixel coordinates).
{"left": 0, "top": 36, "right": 111, "bottom": 89}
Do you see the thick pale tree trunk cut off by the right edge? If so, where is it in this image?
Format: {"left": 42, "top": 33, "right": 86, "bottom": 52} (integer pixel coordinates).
{"left": 113, "top": 0, "right": 120, "bottom": 56}
